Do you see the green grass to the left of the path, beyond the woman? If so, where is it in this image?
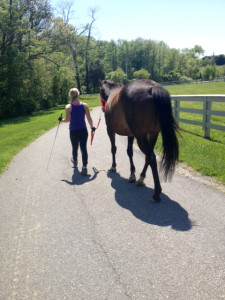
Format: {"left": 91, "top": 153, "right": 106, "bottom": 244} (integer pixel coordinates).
{"left": 0, "top": 94, "right": 100, "bottom": 174}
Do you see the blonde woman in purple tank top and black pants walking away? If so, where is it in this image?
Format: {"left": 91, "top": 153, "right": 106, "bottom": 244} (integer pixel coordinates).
{"left": 58, "top": 88, "right": 95, "bottom": 175}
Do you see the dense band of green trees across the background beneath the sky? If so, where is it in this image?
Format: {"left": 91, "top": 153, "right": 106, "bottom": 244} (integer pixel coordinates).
{"left": 0, "top": 0, "right": 225, "bottom": 118}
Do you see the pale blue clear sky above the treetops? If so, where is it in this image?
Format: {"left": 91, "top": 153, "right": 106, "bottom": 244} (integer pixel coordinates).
{"left": 49, "top": 0, "right": 225, "bottom": 55}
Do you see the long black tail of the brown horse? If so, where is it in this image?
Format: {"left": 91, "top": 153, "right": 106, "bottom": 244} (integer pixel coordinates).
{"left": 149, "top": 86, "right": 179, "bottom": 180}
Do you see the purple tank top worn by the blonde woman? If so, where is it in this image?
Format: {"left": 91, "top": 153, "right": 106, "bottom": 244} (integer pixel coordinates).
{"left": 70, "top": 103, "right": 87, "bottom": 131}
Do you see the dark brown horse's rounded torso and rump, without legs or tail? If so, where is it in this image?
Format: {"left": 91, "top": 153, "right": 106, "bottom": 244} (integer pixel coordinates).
{"left": 105, "top": 80, "right": 170, "bottom": 140}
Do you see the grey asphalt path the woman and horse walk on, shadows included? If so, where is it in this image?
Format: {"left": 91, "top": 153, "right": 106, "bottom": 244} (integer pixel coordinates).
{"left": 0, "top": 108, "right": 225, "bottom": 300}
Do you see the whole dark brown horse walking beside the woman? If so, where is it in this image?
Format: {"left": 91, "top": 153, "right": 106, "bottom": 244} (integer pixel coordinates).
{"left": 100, "top": 80, "right": 179, "bottom": 202}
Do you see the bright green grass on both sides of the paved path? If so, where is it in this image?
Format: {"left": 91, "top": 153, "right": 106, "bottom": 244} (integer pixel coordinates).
{"left": 0, "top": 82, "right": 225, "bottom": 184}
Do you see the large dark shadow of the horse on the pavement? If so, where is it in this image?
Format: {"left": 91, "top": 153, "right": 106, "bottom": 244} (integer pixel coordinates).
{"left": 107, "top": 172, "right": 193, "bottom": 231}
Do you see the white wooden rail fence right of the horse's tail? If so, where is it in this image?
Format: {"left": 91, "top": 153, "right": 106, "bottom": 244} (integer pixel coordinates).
{"left": 171, "top": 95, "right": 225, "bottom": 138}
